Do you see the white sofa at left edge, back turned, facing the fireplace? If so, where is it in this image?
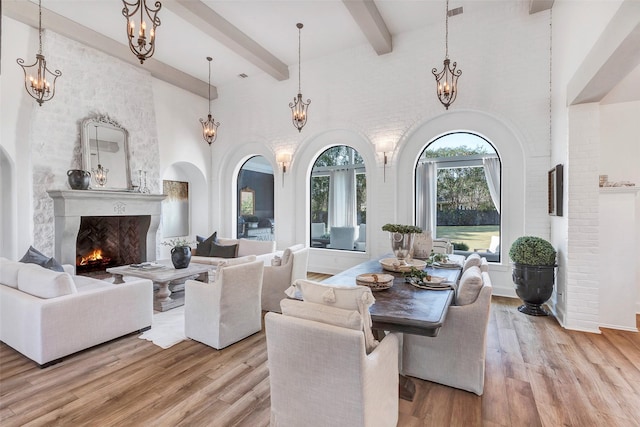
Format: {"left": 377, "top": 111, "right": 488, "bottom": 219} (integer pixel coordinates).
{"left": 0, "top": 258, "right": 153, "bottom": 367}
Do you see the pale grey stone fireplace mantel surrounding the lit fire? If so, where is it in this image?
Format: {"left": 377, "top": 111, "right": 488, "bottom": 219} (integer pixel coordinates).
{"left": 47, "top": 190, "right": 166, "bottom": 265}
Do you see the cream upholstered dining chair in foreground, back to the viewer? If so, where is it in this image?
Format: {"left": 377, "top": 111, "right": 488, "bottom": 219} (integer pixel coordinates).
{"left": 265, "top": 300, "right": 398, "bottom": 427}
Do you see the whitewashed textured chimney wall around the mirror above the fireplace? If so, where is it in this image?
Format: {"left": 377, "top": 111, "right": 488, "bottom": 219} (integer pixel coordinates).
{"left": 25, "top": 31, "right": 161, "bottom": 254}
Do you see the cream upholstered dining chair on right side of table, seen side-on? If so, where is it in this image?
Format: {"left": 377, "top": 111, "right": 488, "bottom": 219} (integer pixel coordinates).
{"left": 402, "top": 267, "right": 492, "bottom": 395}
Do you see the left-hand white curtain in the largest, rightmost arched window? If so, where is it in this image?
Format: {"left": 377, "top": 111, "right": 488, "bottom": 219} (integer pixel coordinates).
{"left": 416, "top": 162, "right": 438, "bottom": 236}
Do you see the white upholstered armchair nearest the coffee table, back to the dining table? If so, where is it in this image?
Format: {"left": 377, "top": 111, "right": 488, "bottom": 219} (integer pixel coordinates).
{"left": 184, "top": 255, "right": 264, "bottom": 349}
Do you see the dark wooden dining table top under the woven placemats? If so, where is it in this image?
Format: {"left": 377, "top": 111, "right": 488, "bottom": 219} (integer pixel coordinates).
{"left": 322, "top": 260, "right": 461, "bottom": 337}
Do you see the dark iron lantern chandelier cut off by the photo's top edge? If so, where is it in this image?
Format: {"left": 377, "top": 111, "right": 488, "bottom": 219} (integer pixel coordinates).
{"left": 122, "top": 0, "right": 162, "bottom": 64}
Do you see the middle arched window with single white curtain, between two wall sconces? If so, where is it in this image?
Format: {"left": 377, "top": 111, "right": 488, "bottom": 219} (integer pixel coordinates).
{"left": 309, "top": 145, "right": 367, "bottom": 251}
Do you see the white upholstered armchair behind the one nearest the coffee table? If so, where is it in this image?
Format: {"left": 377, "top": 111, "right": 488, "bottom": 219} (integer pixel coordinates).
{"left": 262, "top": 244, "right": 309, "bottom": 313}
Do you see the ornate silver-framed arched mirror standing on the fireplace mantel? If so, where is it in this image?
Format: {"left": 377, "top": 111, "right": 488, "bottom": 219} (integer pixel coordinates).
{"left": 82, "top": 116, "right": 131, "bottom": 191}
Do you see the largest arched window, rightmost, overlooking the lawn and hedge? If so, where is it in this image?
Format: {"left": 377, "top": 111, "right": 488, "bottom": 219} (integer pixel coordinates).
{"left": 415, "top": 132, "right": 501, "bottom": 262}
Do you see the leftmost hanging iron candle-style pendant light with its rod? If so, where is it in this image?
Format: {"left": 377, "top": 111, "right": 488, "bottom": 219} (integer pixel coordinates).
{"left": 17, "top": 0, "right": 62, "bottom": 106}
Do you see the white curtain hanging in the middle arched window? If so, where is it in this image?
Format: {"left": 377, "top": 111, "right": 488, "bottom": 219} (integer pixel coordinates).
{"left": 329, "top": 168, "right": 357, "bottom": 227}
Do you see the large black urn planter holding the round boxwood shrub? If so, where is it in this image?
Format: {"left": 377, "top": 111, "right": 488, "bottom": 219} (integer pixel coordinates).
{"left": 513, "top": 264, "right": 556, "bottom": 316}
